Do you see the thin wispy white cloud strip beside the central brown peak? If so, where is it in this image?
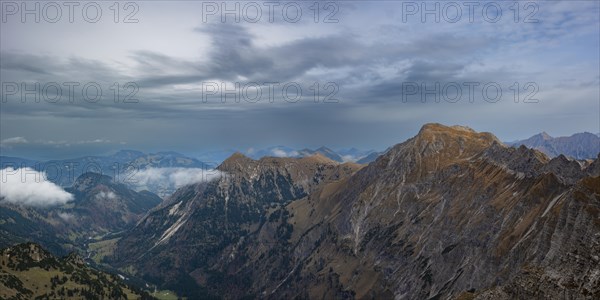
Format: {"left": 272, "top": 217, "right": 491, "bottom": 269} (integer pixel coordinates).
{"left": 127, "top": 168, "right": 221, "bottom": 188}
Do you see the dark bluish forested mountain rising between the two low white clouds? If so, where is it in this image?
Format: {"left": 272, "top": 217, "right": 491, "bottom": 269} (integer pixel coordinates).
{"left": 0, "top": 173, "right": 162, "bottom": 253}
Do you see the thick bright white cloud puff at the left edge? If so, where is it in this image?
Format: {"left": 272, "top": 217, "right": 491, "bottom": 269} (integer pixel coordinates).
{"left": 0, "top": 167, "right": 73, "bottom": 206}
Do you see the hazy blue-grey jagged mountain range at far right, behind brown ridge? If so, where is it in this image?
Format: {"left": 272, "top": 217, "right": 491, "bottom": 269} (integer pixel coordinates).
{"left": 508, "top": 132, "right": 600, "bottom": 159}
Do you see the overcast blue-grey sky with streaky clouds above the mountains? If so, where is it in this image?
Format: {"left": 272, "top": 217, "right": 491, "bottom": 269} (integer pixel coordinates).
{"left": 0, "top": 0, "right": 600, "bottom": 158}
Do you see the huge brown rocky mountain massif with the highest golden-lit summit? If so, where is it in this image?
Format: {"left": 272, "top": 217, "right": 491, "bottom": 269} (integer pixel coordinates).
{"left": 110, "top": 124, "right": 600, "bottom": 299}
